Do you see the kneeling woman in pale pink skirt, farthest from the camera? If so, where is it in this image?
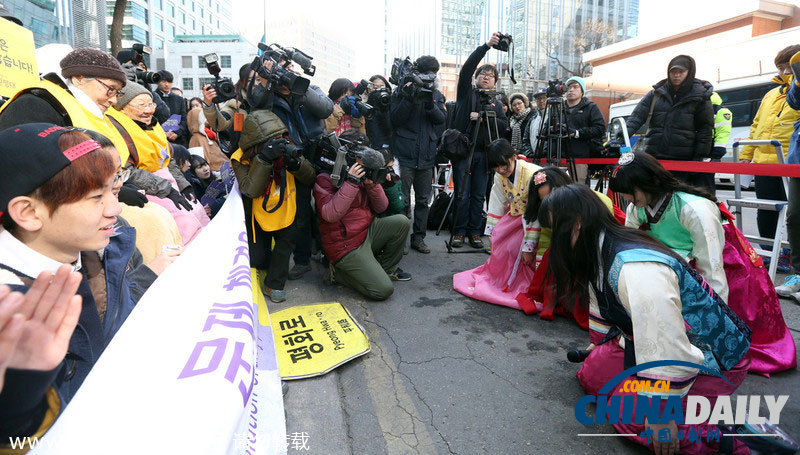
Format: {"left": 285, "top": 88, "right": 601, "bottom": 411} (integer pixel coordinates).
{"left": 453, "top": 139, "right": 540, "bottom": 314}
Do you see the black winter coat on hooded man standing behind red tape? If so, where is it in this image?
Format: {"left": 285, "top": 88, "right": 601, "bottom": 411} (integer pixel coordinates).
{"left": 627, "top": 79, "right": 714, "bottom": 161}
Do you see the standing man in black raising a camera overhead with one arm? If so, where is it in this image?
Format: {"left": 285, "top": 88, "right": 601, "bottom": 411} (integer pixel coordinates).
{"left": 451, "top": 32, "right": 508, "bottom": 248}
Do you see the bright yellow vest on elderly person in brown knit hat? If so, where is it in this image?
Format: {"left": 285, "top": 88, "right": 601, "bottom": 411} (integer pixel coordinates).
{"left": 0, "top": 80, "right": 129, "bottom": 166}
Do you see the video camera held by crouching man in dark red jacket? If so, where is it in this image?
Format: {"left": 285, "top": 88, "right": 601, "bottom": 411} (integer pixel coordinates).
{"left": 317, "top": 133, "right": 394, "bottom": 188}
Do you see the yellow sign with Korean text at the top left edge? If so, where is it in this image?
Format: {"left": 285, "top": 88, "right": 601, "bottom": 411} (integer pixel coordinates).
{"left": 0, "top": 20, "right": 39, "bottom": 98}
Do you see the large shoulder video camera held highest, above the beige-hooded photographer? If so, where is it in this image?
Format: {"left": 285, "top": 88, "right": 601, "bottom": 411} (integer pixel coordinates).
{"left": 250, "top": 43, "right": 317, "bottom": 95}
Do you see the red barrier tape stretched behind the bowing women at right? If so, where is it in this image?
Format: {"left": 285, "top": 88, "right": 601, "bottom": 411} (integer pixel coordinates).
{"left": 540, "top": 158, "right": 800, "bottom": 178}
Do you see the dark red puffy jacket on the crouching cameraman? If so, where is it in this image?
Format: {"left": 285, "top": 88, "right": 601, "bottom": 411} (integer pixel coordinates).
{"left": 314, "top": 174, "right": 389, "bottom": 264}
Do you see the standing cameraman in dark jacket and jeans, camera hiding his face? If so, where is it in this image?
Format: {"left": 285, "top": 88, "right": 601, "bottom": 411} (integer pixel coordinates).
{"left": 390, "top": 55, "right": 447, "bottom": 254}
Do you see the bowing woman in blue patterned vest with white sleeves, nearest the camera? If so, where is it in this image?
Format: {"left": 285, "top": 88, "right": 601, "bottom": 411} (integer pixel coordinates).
{"left": 539, "top": 184, "right": 751, "bottom": 454}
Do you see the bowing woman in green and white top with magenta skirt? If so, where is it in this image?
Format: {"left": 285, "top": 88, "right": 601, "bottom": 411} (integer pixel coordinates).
{"left": 610, "top": 153, "right": 797, "bottom": 373}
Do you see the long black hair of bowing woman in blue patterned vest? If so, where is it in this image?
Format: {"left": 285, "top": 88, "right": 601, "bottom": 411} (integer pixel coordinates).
{"left": 539, "top": 183, "right": 686, "bottom": 305}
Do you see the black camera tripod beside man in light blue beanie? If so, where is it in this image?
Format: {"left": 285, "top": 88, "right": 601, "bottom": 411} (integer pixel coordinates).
{"left": 534, "top": 96, "right": 580, "bottom": 183}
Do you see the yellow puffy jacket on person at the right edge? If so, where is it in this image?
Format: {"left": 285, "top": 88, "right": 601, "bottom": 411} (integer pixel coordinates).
{"left": 739, "top": 76, "right": 800, "bottom": 163}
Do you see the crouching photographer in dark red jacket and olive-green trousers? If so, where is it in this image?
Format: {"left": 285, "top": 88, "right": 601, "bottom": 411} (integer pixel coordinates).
{"left": 314, "top": 145, "right": 411, "bottom": 300}
